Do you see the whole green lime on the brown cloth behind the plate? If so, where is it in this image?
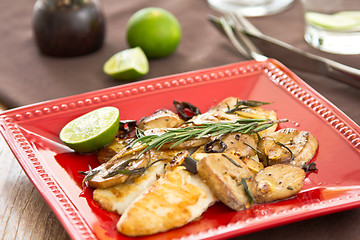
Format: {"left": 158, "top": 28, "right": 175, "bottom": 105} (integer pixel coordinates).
{"left": 126, "top": 7, "right": 181, "bottom": 58}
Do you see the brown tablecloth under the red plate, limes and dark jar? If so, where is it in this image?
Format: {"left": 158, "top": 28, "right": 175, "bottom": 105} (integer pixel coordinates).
{"left": 0, "top": 0, "right": 360, "bottom": 240}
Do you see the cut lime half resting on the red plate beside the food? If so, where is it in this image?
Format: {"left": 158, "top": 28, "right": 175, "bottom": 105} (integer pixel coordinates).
{"left": 60, "top": 107, "right": 119, "bottom": 153}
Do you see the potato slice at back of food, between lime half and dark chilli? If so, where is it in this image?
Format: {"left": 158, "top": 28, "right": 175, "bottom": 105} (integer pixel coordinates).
{"left": 138, "top": 109, "right": 184, "bottom": 131}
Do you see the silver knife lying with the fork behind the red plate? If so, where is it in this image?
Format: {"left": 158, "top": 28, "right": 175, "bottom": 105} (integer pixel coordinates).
{"left": 208, "top": 15, "right": 360, "bottom": 88}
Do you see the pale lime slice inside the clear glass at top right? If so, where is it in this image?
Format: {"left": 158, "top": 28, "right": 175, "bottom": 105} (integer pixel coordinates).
{"left": 305, "top": 12, "right": 359, "bottom": 30}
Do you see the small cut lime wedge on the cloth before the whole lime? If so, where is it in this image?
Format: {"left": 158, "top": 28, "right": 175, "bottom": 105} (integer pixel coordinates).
{"left": 103, "top": 47, "right": 149, "bottom": 80}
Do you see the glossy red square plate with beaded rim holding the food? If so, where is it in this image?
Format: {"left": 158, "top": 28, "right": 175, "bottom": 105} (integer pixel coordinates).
{"left": 0, "top": 60, "right": 360, "bottom": 239}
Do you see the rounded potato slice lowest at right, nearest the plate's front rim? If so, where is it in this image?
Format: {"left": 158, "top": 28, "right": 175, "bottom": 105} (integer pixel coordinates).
{"left": 250, "top": 164, "right": 305, "bottom": 203}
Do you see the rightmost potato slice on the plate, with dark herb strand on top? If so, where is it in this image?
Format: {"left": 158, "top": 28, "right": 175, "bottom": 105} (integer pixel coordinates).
{"left": 258, "top": 128, "right": 318, "bottom": 167}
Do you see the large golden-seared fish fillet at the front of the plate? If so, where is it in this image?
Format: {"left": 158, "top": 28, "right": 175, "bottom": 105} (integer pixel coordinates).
{"left": 116, "top": 167, "right": 216, "bottom": 236}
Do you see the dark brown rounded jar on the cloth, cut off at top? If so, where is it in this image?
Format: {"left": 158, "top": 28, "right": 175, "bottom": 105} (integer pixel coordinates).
{"left": 33, "top": 0, "right": 105, "bottom": 57}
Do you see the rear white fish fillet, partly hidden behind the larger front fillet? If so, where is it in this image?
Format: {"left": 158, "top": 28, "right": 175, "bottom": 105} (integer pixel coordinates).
{"left": 93, "top": 162, "right": 165, "bottom": 215}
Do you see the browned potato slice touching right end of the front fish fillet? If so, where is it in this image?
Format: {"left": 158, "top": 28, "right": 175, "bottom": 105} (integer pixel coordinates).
{"left": 197, "top": 153, "right": 254, "bottom": 210}
